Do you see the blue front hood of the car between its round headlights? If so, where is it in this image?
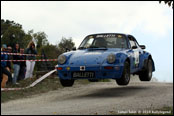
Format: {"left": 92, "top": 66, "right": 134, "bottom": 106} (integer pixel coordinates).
{"left": 68, "top": 49, "right": 125, "bottom": 66}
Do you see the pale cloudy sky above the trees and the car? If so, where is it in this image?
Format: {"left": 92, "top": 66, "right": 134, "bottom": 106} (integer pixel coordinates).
{"left": 1, "top": 1, "right": 173, "bottom": 82}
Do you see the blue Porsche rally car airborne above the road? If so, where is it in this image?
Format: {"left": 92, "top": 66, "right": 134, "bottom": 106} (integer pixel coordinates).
{"left": 57, "top": 33, "right": 155, "bottom": 87}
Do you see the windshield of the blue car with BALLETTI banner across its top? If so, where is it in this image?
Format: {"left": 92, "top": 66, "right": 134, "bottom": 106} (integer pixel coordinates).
{"left": 79, "top": 34, "right": 127, "bottom": 49}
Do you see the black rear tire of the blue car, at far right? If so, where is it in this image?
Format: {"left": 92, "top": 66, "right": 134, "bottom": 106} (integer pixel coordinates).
{"left": 139, "top": 59, "right": 152, "bottom": 81}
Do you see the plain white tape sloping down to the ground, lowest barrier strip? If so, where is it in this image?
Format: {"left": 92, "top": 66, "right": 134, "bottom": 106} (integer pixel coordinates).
{"left": 1, "top": 69, "right": 56, "bottom": 91}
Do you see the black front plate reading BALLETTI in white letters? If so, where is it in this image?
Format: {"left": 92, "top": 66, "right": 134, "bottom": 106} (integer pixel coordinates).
{"left": 72, "top": 71, "right": 95, "bottom": 78}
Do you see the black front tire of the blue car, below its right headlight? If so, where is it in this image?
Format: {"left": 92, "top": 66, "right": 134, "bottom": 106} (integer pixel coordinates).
{"left": 116, "top": 61, "right": 130, "bottom": 85}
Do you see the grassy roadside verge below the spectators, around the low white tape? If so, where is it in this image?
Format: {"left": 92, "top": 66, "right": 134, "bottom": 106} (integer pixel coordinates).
{"left": 1, "top": 74, "right": 89, "bottom": 103}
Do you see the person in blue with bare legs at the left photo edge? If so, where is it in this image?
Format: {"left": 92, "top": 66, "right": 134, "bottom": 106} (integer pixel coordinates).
{"left": 1, "top": 44, "right": 12, "bottom": 88}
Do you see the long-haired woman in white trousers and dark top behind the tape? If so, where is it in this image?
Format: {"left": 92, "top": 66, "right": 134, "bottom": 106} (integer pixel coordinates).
{"left": 25, "top": 41, "right": 37, "bottom": 79}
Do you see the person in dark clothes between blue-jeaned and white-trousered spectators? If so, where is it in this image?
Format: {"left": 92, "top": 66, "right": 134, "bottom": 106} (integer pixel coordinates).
{"left": 18, "top": 49, "right": 26, "bottom": 81}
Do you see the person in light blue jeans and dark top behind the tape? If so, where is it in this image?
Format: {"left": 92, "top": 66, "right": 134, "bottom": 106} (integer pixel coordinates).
{"left": 13, "top": 44, "right": 21, "bottom": 84}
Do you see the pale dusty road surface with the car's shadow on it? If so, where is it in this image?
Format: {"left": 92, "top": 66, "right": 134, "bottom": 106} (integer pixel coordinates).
{"left": 1, "top": 80, "right": 173, "bottom": 115}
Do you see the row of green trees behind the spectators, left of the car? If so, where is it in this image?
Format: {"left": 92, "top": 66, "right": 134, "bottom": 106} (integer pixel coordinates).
{"left": 1, "top": 19, "right": 75, "bottom": 71}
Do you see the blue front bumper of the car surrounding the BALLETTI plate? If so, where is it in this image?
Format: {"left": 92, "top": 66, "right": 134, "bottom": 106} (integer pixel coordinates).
{"left": 57, "top": 65, "right": 123, "bottom": 79}
